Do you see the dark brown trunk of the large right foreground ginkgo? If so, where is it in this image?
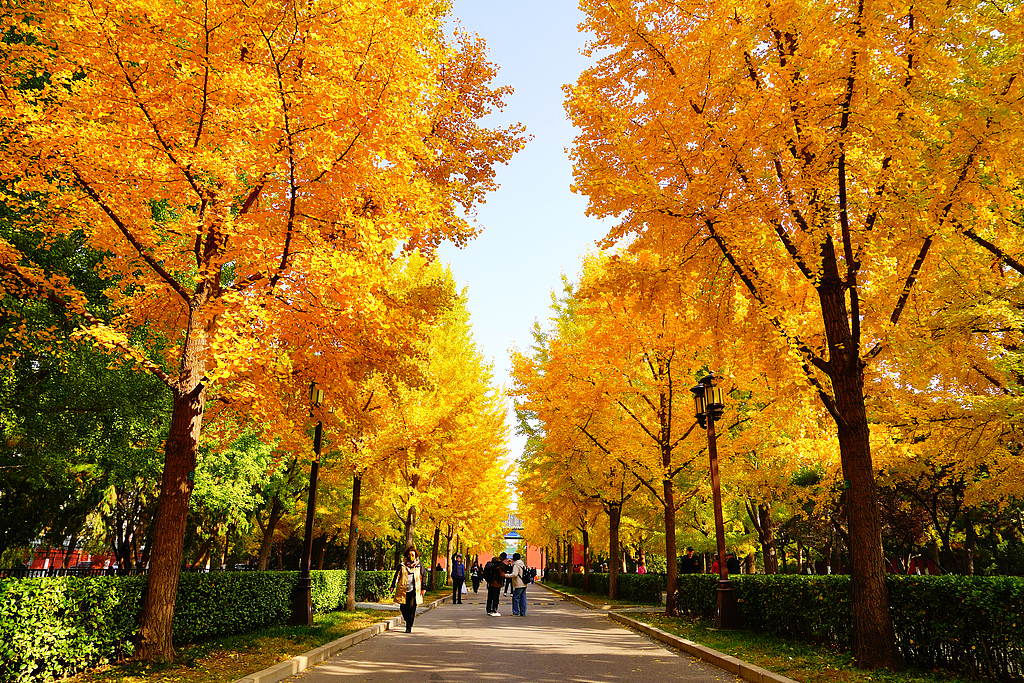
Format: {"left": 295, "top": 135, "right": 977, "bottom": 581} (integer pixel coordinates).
{"left": 818, "top": 242, "right": 903, "bottom": 670}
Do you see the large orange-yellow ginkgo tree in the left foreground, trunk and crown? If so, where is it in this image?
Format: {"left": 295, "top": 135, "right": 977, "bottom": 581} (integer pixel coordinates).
{"left": 0, "top": 0, "right": 523, "bottom": 659}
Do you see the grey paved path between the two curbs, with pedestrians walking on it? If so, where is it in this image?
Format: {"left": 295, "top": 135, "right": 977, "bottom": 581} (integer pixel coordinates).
{"left": 287, "top": 586, "right": 738, "bottom": 683}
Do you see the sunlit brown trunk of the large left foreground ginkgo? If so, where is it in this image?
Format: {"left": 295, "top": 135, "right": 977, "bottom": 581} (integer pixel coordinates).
{"left": 135, "top": 313, "right": 206, "bottom": 661}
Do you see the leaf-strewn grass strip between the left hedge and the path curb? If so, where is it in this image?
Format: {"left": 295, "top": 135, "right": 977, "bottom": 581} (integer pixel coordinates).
{"left": 62, "top": 591, "right": 451, "bottom": 683}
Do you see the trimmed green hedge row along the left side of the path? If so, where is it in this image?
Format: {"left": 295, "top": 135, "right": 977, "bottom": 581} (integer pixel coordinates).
{"left": 0, "top": 569, "right": 391, "bottom": 683}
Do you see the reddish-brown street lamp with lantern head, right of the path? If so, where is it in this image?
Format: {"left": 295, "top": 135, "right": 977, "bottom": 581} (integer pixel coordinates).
{"left": 690, "top": 373, "right": 739, "bottom": 629}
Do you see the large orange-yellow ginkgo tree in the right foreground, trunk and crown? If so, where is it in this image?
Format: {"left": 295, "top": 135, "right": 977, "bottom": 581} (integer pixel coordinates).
{"left": 567, "top": 0, "right": 1024, "bottom": 668}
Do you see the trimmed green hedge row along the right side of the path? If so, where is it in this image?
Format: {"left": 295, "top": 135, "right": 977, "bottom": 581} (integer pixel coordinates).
{"left": 677, "top": 574, "right": 1024, "bottom": 680}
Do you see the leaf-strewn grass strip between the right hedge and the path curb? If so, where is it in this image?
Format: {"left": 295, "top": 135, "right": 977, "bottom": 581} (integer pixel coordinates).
{"left": 629, "top": 612, "right": 977, "bottom": 683}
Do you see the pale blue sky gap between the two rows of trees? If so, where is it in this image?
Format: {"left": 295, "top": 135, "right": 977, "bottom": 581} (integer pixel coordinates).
{"left": 440, "top": 0, "right": 607, "bottom": 457}
